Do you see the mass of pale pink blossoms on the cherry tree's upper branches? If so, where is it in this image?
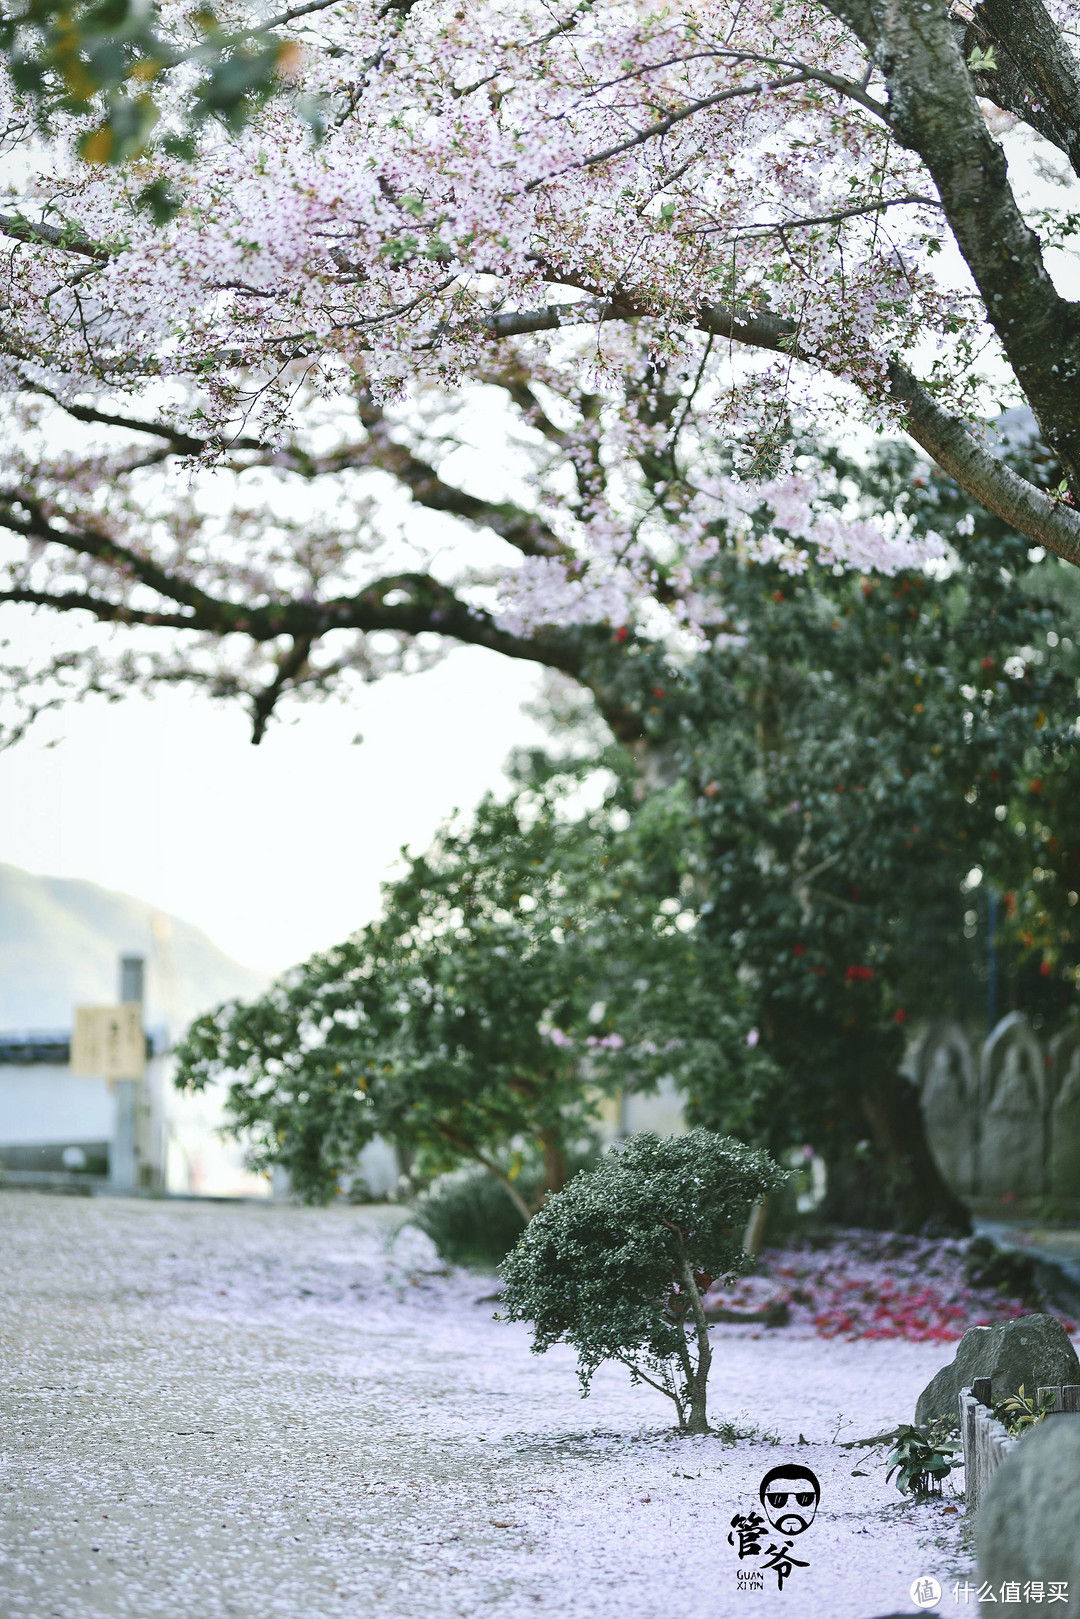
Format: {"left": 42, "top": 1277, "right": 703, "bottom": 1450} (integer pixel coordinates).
{"left": 0, "top": 0, "right": 1077, "bottom": 663}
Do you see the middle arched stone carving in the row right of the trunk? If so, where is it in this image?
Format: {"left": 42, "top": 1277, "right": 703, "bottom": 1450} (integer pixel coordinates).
{"left": 978, "top": 1012, "right": 1046, "bottom": 1198}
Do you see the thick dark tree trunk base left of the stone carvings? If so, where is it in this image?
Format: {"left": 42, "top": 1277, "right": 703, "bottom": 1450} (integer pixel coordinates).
{"left": 824, "top": 1069, "right": 972, "bottom": 1235}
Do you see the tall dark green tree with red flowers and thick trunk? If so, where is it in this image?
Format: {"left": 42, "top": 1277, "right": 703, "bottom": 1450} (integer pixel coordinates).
{"left": 563, "top": 433, "right": 1080, "bottom": 1230}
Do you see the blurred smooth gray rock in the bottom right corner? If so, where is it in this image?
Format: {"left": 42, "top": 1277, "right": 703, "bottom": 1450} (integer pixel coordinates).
{"left": 975, "top": 1417, "right": 1080, "bottom": 1613}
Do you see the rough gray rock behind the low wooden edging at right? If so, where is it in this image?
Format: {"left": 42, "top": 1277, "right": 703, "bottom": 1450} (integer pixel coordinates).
{"left": 915, "top": 1315, "right": 1080, "bottom": 1421}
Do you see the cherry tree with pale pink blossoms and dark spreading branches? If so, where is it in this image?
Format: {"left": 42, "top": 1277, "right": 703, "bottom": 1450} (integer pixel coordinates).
{"left": 0, "top": 0, "right": 1080, "bottom": 740}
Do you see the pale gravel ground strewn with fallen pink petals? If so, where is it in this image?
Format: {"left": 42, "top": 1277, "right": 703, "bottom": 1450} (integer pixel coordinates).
{"left": 0, "top": 1193, "right": 963, "bottom": 1619}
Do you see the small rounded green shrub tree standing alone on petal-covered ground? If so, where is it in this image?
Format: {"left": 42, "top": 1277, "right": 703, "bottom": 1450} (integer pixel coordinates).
{"left": 502, "top": 1130, "right": 785, "bottom": 1433}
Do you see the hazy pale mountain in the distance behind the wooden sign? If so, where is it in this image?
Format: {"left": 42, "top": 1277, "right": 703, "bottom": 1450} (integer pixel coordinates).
{"left": 0, "top": 865, "right": 269, "bottom": 1036}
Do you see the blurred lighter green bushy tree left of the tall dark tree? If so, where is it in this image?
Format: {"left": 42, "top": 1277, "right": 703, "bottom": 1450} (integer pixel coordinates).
{"left": 176, "top": 779, "right": 767, "bottom": 1221}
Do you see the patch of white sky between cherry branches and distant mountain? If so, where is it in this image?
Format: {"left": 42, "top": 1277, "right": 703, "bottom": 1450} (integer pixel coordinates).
{"left": 0, "top": 644, "right": 539, "bottom": 971}
